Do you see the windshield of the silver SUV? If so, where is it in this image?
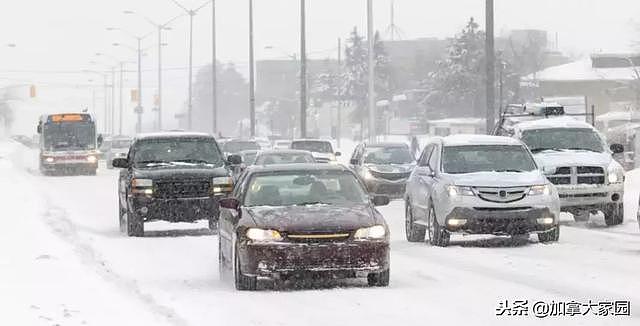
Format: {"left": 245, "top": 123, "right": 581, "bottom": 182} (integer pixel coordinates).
{"left": 442, "top": 145, "right": 536, "bottom": 174}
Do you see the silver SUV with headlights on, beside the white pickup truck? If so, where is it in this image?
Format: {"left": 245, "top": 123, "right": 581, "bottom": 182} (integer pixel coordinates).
{"left": 405, "top": 135, "right": 560, "bottom": 246}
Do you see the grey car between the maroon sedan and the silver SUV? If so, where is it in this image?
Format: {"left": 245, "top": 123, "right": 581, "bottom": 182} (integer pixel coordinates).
{"left": 349, "top": 143, "right": 416, "bottom": 198}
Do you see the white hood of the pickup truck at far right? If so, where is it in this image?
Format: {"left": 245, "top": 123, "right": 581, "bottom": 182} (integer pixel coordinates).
{"left": 533, "top": 150, "right": 612, "bottom": 168}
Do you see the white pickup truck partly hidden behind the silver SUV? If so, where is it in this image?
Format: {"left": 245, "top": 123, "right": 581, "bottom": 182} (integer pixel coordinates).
{"left": 512, "top": 116, "right": 624, "bottom": 225}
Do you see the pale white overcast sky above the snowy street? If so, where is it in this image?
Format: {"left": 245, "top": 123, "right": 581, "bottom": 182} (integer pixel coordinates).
{"left": 0, "top": 0, "right": 640, "bottom": 131}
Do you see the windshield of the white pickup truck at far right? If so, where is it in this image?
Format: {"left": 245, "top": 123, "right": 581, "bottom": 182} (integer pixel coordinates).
{"left": 522, "top": 128, "right": 604, "bottom": 153}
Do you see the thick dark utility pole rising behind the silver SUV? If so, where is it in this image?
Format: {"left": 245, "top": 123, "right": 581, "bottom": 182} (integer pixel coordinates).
{"left": 485, "top": 0, "right": 496, "bottom": 134}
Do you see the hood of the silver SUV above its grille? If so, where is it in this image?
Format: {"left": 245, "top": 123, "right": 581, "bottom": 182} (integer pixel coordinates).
{"left": 448, "top": 170, "right": 547, "bottom": 187}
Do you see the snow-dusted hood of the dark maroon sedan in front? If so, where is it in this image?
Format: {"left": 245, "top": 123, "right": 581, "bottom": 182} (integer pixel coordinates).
{"left": 245, "top": 204, "right": 382, "bottom": 233}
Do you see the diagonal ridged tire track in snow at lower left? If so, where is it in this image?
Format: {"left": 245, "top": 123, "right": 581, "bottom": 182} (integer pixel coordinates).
{"left": 43, "top": 199, "right": 188, "bottom": 326}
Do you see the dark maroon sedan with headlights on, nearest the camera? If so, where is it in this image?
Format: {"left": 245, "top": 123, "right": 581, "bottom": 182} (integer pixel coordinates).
{"left": 219, "top": 164, "right": 389, "bottom": 290}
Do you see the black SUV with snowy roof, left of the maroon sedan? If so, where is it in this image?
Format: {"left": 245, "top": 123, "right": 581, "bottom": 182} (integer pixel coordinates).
{"left": 113, "top": 133, "right": 240, "bottom": 236}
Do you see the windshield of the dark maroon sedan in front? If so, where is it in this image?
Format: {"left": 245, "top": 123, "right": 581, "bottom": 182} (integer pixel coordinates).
{"left": 244, "top": 171, "right": 368, "bottom": 206}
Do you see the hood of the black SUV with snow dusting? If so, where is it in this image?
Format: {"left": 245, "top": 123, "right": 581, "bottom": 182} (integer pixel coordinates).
{"left": 133, "top": 165, "right": 229, "bottom": 180}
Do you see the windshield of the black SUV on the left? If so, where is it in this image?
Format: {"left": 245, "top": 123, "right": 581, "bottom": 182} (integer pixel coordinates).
{"left": 133, "top": 138, "right": 223, "bottom": 165}
